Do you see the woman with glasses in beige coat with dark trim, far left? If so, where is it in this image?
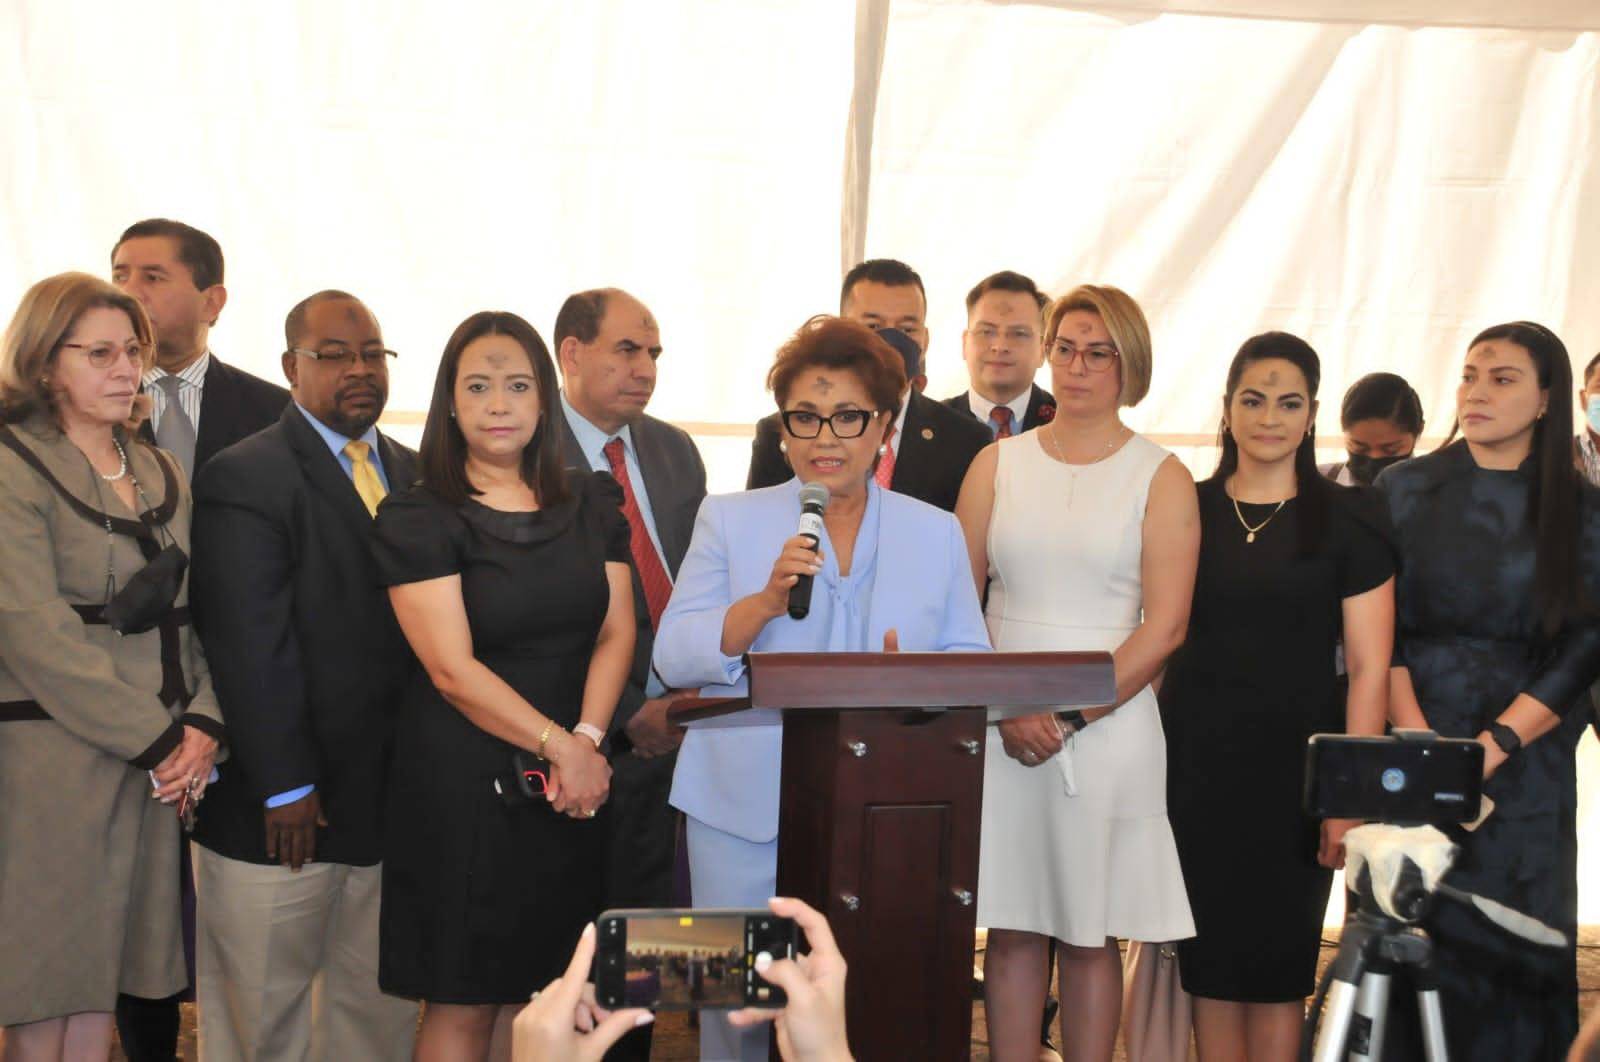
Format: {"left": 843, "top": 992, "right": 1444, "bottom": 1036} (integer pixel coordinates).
{"left": 0, "top": 273, "right": 222, "bottom": 1062}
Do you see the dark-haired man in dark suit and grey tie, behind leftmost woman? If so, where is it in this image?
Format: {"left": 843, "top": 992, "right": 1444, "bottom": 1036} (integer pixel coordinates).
{"left": 110, "top": 218, "right": 290, "bottom": 1062}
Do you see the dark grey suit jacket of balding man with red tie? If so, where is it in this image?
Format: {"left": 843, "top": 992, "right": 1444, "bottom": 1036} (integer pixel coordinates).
{"left": 555, "top": 406, "right": 706, "bottom": 738}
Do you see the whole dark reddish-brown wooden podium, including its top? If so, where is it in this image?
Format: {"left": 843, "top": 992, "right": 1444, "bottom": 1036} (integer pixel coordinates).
{"left": 670, "top": 653, "right": 1115, "bottom": 1062}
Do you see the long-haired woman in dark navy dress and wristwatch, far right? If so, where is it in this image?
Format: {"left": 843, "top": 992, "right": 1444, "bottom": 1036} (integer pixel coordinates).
{"left": 1378, "top": 321, "right": 1600, "bottom": 1062}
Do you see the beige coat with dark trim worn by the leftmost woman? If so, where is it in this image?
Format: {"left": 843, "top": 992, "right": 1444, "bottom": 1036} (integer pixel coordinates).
{"left": 0, "top": 417, "right": 221, "bottom": 1025}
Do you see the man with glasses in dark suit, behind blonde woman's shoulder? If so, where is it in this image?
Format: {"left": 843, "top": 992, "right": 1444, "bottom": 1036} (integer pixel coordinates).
{"left": 944, "top": 270, "right": 1056, "bottom": 438}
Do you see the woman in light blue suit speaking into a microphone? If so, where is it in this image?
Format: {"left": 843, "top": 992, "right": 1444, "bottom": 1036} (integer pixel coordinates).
{"left": 654, "top": 317, "right": 989, "bottom": 1059}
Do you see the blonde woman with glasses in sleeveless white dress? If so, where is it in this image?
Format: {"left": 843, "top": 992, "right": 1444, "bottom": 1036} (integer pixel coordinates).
{"left": 955, "top": 285, "right": 1200, "bottom": 1062}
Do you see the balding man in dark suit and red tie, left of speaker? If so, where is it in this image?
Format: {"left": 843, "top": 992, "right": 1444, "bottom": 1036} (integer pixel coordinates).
{"left": 555, "top": 288, "right": 706, "bottom": 1059}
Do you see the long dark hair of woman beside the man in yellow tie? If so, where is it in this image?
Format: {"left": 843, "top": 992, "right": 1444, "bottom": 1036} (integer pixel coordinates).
{"left": 418, "top": 310, "right": 568, "bottom": 507}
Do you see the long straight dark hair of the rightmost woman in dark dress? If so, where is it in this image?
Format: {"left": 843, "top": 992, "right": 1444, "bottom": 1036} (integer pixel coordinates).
{"left": 1445, "top": 321, "right": 1589, "bottom": 640}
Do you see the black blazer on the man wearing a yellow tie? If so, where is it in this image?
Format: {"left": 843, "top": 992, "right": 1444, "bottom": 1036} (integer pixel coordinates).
{"left": 190, "top": 404, "right": 418, "bottom": 865}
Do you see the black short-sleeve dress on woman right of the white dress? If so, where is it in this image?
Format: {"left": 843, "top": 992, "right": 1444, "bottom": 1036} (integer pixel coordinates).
{"left": 1160, "top": 478, "right": 1395, "bottom": 1003}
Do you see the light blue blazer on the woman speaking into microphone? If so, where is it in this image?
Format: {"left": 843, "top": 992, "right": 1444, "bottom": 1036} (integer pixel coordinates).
{"left": 654, "top": 478, "right": 989, "bottom": 843}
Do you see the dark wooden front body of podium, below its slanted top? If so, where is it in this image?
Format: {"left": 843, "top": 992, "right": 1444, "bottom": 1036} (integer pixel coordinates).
{"left": 778, "top": 709, "right": 984, "bottom": 1060}
